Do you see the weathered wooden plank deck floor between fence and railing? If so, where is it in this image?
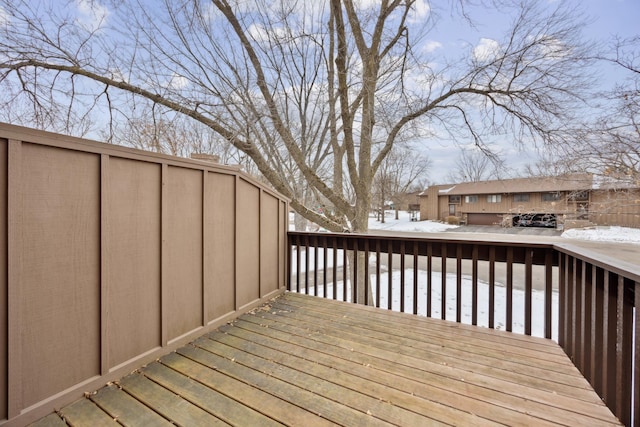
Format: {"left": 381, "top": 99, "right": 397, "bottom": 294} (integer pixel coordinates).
{"left": 30, "top": 293, "right": 619, "bottom": 427}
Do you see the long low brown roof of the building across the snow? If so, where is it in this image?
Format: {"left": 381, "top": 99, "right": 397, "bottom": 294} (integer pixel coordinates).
{"left": 430, "top": 174, "right": 593, "bottom": 195}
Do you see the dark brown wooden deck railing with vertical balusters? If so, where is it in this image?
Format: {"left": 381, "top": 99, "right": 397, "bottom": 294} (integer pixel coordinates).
{"left": 288, "top": 232, "right": 640, "bottom": 425}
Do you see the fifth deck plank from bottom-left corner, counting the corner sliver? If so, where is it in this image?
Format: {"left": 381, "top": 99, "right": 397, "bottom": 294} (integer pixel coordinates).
{"left": 141, "top": 363, "right": 281, "bottom": 427}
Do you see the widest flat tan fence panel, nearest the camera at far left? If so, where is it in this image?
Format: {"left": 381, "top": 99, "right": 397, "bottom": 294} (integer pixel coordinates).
{"left": 18, "top": 143, "right": 102, "bottom": 407}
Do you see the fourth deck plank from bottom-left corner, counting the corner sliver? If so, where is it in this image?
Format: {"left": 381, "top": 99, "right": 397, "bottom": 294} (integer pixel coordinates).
{"left": 120, "top": 373, "right": 228, "bottom": 426}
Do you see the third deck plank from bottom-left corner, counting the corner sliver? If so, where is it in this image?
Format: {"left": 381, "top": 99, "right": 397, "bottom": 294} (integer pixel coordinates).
{"left": 89, "top": 385, "right": 173, "bottom": 427}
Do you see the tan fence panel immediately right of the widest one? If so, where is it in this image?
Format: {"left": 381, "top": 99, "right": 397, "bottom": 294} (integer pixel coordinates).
{"left": 102, "top": 158, "right": 162, "bottom": 368}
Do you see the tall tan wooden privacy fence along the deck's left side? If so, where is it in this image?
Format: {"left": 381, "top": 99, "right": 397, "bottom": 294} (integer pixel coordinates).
{"left": 0, "top": 124, "right": 288, "bottom": 424}
